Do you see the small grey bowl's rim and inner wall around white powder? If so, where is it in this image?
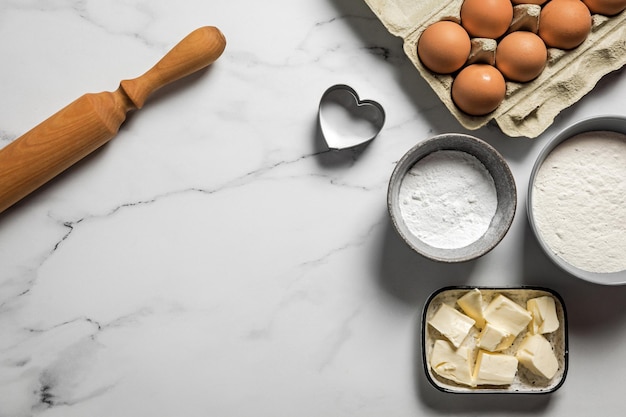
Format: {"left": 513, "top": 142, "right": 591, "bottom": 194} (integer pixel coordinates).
{"left": 387, "top": 133, "right": 517, "bottom": 263}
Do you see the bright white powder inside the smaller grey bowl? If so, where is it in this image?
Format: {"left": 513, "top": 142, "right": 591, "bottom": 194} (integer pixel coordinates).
{"left": 399, "top": 150, "right": 498, "bottom": 249}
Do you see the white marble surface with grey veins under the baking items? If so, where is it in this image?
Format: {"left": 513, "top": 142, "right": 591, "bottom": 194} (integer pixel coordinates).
{"left": 0, "top": 0, "right": 626, "bottom": 417}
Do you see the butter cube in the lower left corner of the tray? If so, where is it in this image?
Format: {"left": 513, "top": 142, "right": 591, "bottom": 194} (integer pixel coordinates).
{"left": 430, "top": 340, "right": 474, "bottom": 386}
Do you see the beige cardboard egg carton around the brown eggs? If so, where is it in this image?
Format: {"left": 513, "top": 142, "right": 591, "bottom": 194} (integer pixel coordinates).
{"left": 365, "top": 0, "right": 626, "bottom": 138}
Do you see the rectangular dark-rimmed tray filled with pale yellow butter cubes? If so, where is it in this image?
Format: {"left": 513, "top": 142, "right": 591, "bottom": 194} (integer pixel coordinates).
{"left": 422, "top": 287, "right": 568, "bottom": 394}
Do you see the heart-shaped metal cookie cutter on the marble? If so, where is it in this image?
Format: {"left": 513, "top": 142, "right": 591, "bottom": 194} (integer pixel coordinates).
{"left": 317, "top": 84, "right": 385, "bottom": 150}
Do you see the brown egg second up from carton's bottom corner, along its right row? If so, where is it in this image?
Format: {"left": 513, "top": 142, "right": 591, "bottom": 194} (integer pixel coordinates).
{"left": 496, "top": 31, "right": 548, "bottom": 82}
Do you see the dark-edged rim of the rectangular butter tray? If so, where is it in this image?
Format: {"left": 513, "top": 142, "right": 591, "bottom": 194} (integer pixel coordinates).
{"left": 420, "top": 285, "right": 569, "bottom": 395}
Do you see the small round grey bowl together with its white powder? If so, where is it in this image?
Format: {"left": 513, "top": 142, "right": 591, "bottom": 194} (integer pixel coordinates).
{"left": 387, "top": 133, "right": 517, "bottom": 262}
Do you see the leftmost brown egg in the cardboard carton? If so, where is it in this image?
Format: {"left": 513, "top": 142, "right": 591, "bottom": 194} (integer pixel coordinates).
{"left": 417, "top": 20, "right": 471, "bottom": 74}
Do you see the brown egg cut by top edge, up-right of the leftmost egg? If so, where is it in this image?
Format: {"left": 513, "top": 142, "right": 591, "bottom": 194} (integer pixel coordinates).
{"left": 461, "top": 0, "right": 513, "bottom": 39}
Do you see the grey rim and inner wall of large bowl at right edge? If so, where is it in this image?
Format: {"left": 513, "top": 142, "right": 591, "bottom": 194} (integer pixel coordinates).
{"left": 526, "top": 115, "right": 626, "bottom": 285}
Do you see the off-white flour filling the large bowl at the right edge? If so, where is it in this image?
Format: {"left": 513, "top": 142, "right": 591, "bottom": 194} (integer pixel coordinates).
{"left": 532, "top": 132, "right": 626, "bottom": 273}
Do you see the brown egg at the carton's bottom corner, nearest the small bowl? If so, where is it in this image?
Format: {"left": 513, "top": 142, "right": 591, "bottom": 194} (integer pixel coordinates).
{"left": 452, "top": 64, "right": 506, "bottom": 116}
